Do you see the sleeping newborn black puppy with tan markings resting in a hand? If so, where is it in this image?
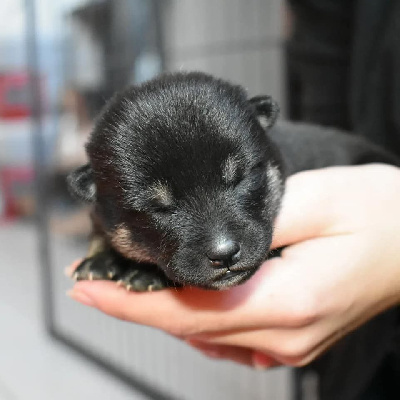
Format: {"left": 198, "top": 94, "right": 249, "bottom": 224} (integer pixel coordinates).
{"left": 68, "top": 73, "right": 395, "bottom": 291}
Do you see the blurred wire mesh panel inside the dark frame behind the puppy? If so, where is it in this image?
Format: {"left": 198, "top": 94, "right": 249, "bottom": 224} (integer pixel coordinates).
{"left": 37, "top": 0, "right": 291, "bottom": 400}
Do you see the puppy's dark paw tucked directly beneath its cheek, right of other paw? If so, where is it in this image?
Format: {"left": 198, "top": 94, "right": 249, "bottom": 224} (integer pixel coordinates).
{"left": 117, "top": 264, "right": 176, "bottom": 292}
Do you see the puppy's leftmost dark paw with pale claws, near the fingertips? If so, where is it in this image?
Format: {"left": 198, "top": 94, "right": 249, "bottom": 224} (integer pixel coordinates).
{"left": 72, "top": 251, "right": 121, "bottom": 281}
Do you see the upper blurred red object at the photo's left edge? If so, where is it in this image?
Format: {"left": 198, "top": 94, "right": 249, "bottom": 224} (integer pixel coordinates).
{"left": 0, "top": 72, "right": 43, "bottom": 119}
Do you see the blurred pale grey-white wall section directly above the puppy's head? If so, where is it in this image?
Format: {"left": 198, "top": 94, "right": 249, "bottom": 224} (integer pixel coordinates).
{"left": 163, "top": 0, "right": 284, "bottom": 112}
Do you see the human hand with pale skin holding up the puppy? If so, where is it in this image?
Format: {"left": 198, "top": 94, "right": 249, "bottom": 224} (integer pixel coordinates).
{"left": 65, "top": 165, "right": 400, "bottom": 366}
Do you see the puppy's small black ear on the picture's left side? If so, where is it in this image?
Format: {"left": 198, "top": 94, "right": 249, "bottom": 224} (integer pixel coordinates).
{"left": 67, "top": 164, "right": 96, "bottom": 203}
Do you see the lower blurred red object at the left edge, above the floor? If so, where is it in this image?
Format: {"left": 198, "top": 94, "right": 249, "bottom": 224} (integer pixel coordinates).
{"left": 0, "top": 167, "right": 34, "bottom": 222}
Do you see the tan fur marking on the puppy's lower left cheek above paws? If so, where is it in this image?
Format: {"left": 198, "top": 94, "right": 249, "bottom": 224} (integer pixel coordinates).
{"left": 109, "top": 224, "right": 155, "bottom": 263}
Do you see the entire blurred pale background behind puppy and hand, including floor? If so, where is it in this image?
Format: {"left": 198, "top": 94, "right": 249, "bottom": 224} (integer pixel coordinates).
{"left": 0, "top": 0, "right": 291, "bottom": 400}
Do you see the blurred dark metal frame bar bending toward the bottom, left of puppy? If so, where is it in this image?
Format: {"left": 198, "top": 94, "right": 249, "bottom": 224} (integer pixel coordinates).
{"left": 24, "top": 0, "right": 175, "bottom": 400}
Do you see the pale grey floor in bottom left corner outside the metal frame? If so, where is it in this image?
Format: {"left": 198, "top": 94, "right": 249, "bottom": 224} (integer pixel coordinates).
{"left": 0, "top": 223, "right": 147, "bottom": 400}
